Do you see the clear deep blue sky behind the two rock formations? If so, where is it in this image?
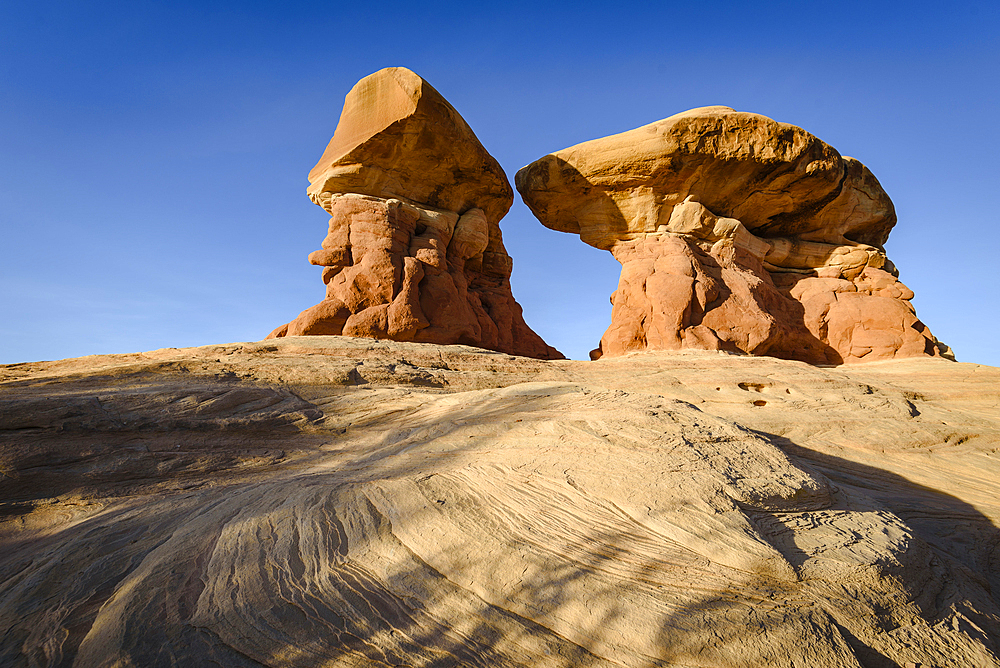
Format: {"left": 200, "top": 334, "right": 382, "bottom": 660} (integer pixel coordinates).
{"left": 0, "top": 0, "right": 1000, "bottom": 366}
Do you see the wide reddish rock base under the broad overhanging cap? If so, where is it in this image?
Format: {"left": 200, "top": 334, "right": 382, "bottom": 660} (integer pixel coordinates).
{"left": 591, "top": 202, "right": 949, "bottom": 364}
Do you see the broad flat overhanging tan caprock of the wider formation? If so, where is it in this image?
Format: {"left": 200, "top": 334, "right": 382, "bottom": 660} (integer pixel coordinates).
{"left": 515, "top": 106, "right": 896, "bottom": 250}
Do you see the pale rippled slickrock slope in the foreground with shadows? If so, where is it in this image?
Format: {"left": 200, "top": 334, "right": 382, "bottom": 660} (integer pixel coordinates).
{"left": 0, "top": 336, "right": 1000, "bottom": 668}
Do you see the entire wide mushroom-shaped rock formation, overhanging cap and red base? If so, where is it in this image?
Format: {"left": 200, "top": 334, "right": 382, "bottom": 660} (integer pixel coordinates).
{"left": 516, "top": 107, "right": 947, "bottom": 364}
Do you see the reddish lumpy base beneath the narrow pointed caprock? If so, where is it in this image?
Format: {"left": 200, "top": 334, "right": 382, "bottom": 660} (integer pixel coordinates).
{"left": 268, "top": 194, "right": 562, "bottom": 359}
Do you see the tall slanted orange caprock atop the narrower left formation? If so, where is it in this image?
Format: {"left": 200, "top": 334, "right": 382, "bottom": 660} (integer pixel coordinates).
{"left": 306, "top": 67, "right": 514, "bottom": 224}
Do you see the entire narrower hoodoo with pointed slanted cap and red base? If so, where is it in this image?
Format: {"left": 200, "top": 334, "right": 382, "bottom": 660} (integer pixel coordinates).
{"left": 269, "top": 67, "right": 562, "bottom": 359}
